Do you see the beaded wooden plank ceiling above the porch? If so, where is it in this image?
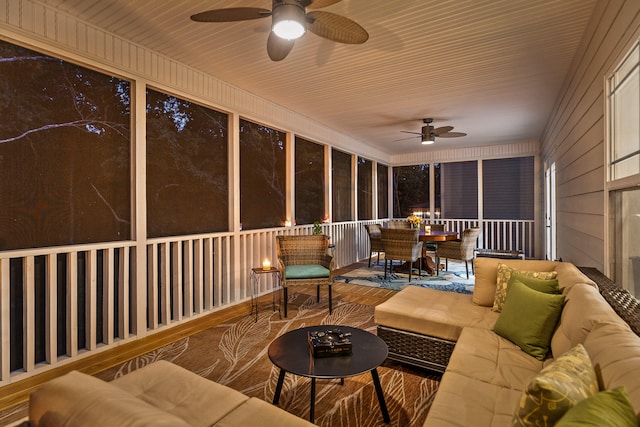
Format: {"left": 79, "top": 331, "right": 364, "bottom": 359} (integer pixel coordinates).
{"left": 39, "top": 0, "right": 596, "bottom": 155}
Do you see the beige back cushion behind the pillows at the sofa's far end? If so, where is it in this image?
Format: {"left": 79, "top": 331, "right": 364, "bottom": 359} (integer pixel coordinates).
{"left": 473, "top": 257, "right": 560, "bottom": 307}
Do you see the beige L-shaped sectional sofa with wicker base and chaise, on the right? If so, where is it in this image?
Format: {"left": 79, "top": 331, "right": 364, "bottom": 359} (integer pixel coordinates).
{"left": 375, "top": 258, "right": 640, "bottom": 427}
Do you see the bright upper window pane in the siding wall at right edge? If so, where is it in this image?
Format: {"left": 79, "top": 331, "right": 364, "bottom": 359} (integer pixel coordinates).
{"left": 609, "top": 44, "right": 640, "bottom": 180}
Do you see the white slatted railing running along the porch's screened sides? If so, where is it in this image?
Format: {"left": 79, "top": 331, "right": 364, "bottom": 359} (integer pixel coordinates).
{"left": 0, "top": 220, "right": 535, "bottom": 386}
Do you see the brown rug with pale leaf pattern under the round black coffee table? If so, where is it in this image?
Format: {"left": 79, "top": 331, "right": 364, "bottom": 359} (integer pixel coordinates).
{"left": 91, "top": 293, "right": 439, "bottom": 427}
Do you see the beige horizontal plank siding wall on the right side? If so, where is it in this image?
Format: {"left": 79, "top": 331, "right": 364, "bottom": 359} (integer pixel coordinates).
{"left": 541, "top": 0, "right": 640, "bottom": 271}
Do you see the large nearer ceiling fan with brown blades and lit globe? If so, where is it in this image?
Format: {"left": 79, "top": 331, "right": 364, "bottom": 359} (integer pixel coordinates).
{"left": 191, "top": 0, "right": 369, "bottom": 61}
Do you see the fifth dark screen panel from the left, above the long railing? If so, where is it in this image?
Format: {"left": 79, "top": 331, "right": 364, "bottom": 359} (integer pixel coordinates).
{"left": 331, "top": 150, "right": 353, "bottom": 222}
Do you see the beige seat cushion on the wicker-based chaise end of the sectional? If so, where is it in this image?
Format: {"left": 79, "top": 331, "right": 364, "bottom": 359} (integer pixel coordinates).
{"left": 374, "top": 286, "right": 498, "bottom": 341}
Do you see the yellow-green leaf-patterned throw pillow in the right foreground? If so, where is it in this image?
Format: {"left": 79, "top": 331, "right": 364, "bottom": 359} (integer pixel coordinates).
{"left": 513, "top": 344, "right": 605, "bottom": 426}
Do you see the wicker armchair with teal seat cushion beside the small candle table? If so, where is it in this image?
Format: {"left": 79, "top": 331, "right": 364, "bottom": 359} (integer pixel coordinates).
{"left": 276, "top": 234, "right": 334, "bottom": 317}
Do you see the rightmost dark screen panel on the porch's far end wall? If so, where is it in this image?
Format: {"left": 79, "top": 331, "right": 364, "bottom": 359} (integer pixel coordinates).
{"left": 482, "top": 157, "right": 534, "bottom": 220}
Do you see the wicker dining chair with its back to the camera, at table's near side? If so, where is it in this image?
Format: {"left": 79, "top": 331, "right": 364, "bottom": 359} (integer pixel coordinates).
{"left": 380, "top": 228, "right": 422, "bottom": 281}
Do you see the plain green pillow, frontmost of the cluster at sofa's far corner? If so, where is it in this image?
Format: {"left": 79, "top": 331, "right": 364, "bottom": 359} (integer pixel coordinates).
{"left": 493, "top": 281, "right": 564, "bottom": 360}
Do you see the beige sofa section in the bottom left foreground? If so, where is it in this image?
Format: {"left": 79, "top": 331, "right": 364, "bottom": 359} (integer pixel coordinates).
{"left": 29, "top": 361, "right": 313, "bottom": 427}
